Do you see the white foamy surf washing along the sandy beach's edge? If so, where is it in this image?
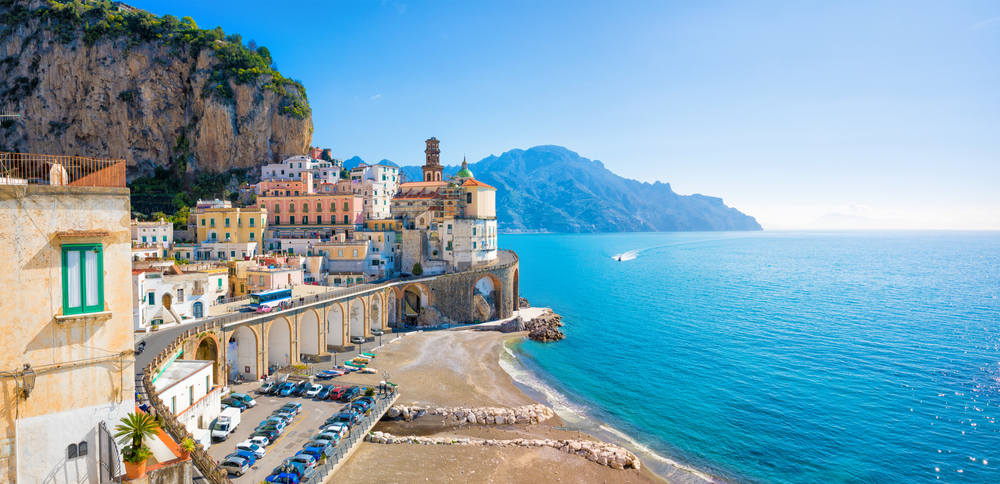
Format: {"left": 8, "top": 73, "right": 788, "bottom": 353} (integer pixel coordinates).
{"left": 500, "top": 340, "right": 726, "bottom": 484}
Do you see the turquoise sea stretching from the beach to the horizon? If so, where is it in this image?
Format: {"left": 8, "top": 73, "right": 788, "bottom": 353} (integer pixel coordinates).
{"left": 500, "top": 232, "right": 1000, "bottom": 484}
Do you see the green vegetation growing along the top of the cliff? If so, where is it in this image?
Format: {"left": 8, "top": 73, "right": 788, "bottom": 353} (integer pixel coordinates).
{"left": 0, "top": 0, "right": 311, "bottom": 119}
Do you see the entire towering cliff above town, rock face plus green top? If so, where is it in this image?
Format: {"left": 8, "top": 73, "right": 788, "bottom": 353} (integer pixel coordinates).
{"left": 0, "top": 0, "right": 313, "bottom": 179}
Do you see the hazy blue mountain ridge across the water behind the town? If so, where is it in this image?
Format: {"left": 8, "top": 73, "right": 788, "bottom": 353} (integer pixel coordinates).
{"left": 401, "top": 145, "right": 763, "bottom": 232}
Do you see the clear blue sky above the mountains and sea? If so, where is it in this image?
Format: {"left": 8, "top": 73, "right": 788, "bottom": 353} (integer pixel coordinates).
{"left": 131, "top": 0, "right": 1000, "bottom": 229}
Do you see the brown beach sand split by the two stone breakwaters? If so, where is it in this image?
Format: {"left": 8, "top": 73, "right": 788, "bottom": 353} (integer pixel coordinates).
{"left": 332, "top": 331, "right": 665, "bottom": 483}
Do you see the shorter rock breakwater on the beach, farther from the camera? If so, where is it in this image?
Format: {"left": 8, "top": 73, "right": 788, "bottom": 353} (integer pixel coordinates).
{"left": 388, "top": 404, "right": 555, "bottom": 425}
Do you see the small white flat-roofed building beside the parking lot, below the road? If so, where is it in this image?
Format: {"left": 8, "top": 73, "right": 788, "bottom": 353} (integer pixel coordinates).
{"left": 153, "top": 359, "right": 222, "bottom": 448}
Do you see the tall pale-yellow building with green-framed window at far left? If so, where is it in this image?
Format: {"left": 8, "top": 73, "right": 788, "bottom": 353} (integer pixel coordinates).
{"left": 0, "top": 153, "right": 136, "bottom": 484}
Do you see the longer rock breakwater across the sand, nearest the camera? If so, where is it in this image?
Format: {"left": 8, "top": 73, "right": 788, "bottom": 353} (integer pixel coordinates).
{"left": 365, "top": 432, "right": 642, "bottom": 470}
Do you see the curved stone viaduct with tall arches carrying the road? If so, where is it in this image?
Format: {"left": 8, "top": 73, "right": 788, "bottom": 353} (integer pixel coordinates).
{"left": 157, "top": 251, "right": 519, "bottom": 382}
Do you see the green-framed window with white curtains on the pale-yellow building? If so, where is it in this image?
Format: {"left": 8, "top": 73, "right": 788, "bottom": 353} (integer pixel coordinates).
{"left": 62, "top": 244, "right": 104, "bottom": 315}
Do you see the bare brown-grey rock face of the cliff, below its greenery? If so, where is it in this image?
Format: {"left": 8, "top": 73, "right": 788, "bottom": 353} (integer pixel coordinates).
{"left": 0, "top": 2, "right": 313, "bottom": 179}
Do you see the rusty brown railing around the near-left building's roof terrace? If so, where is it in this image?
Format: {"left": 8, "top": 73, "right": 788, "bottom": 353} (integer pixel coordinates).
{"left": 0, "top": 153, "right": 125, "bottom": 188}
